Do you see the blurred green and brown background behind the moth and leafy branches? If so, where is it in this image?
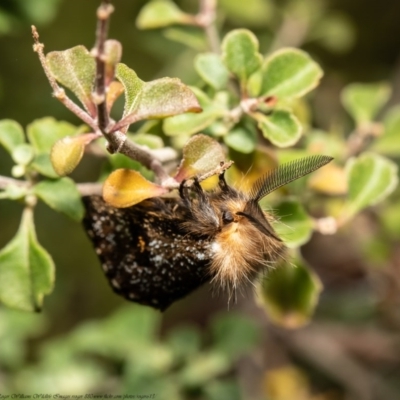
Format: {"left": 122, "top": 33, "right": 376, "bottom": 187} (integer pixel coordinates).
{"left": 0, "top": 0, "right": 400, "bottom": 400}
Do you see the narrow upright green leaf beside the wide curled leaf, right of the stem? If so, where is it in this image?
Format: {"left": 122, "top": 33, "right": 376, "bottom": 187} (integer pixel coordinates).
{"left": 115, "top": 63, "right": 144, "bottom": 116}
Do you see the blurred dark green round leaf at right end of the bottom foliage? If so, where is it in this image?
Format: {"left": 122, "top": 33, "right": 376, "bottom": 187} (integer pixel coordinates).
{"left": 211, "top": 313, "right": 260, "bottom": 361}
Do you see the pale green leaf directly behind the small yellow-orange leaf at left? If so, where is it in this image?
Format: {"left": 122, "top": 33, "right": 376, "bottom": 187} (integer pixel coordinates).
{"left": 27, "top": 117, "right": 78, "bottom": 178}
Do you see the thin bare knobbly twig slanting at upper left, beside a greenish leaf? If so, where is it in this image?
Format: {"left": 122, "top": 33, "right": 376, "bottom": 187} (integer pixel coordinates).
{"left": 32, "top": 25, "right": 98, "bottom": 131}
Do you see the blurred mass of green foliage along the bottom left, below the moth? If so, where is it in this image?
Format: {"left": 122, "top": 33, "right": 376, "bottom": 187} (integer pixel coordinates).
{"left": 0, "top": 305, "right": 260, "bottom": 399}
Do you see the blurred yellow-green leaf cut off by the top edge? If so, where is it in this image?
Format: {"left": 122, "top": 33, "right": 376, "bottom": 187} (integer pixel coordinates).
{"left": 136, "top": 0, "right": 193, "bottom": 29}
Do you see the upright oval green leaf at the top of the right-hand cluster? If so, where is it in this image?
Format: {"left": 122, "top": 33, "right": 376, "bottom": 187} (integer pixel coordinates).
{"left": 221, "top": 29, "right": 262, "bottom": 83}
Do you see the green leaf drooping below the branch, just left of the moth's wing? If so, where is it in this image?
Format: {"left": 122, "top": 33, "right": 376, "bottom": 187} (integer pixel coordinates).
{"left": 33, "top": 178, "right": 84, "bottom": 221}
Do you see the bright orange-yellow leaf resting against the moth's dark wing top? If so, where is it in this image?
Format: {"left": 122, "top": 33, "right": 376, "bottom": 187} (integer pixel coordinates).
{"left": 103, "top": 169, "right": 168, "bottom": 208}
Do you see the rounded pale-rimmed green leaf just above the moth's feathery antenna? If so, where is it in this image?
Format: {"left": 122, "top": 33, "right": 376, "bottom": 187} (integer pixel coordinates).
{"left": 256, "top": 110, "right": 302, "bottom": 147}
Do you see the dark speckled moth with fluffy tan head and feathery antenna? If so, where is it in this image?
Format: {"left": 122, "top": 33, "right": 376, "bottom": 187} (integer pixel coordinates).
{"left": 83, "top": 156, "right": 332, "bottom": 311}
